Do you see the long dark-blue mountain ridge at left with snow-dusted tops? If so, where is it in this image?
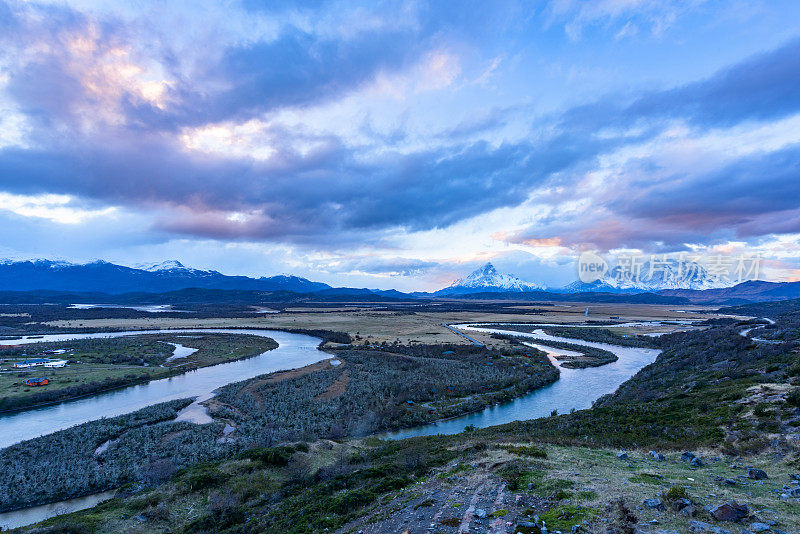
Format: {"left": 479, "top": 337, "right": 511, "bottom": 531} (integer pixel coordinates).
{"left": 0, "top": 260, "right": 331, "bottom": 294}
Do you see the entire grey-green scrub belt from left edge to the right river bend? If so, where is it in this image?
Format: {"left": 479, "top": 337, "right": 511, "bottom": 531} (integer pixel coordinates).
{"left": 0, "top": 345, "right": 558, "bottom": 511}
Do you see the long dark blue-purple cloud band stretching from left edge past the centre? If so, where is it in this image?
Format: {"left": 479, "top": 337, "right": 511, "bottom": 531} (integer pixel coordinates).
{"left": 0, "top": 134, "right": 608, "bottom": 241}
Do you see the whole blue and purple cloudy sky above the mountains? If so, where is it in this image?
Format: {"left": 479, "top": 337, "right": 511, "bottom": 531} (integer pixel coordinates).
{"left": 0, "top": 0, "right": 800, "bottom": 290}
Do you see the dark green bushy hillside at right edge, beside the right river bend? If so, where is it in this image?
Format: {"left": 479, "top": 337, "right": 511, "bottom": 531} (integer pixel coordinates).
{"left": 481, "top": 321, "right": 800, "bottom": 455}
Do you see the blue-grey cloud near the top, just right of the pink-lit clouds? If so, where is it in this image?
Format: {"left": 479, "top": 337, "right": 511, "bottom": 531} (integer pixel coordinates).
{"left": 169, "top": 29, "right": 425, "bottom": 125}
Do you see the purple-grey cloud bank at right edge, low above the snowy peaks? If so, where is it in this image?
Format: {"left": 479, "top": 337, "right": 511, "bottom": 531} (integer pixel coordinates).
{"left": 513, "top": 145, "right": 800, "bottom": 252}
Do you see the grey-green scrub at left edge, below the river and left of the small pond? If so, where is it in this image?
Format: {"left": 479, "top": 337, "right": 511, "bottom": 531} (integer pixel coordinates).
{"left": 0, "top": 399, "right": 230, "bottom": 512}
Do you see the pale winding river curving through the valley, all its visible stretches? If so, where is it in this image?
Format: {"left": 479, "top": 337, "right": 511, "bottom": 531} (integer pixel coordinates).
{"left": 0, "top": 323, "right": 659, "bottom": 529}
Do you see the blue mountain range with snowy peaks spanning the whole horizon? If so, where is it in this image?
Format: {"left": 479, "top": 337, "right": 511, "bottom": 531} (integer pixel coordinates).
{"left": 0, "top": 260, "right": 800, "bottom": 304}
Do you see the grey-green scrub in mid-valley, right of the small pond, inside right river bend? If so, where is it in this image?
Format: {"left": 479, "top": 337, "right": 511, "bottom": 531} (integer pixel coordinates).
{"left": 214, "top": 349, "right": 558, "bottom": 445}
